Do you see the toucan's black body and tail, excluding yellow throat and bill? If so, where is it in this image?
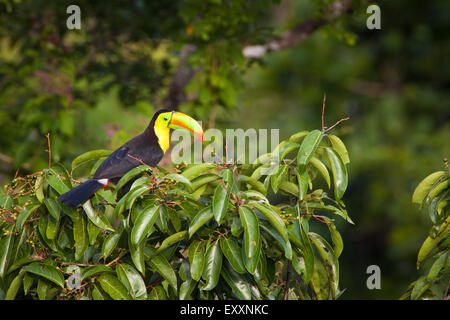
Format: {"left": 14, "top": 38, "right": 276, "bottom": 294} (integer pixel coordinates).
{"left": 58, "top": 110, "right": 169, "bottom": 207}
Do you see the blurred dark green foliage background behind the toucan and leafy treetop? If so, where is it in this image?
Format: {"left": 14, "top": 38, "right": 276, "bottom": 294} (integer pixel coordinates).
{"left": 0, "top": 0, "right": 450, "bottom": 299}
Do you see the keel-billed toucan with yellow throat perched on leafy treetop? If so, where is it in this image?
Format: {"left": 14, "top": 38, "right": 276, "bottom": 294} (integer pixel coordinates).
{"left": 58, "top": 110, "right": 203, "bottom": 207}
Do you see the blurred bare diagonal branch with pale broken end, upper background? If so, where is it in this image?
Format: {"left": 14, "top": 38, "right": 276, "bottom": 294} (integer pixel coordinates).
{"left": 242, "top": 0, "right": 352, "bottom": 58}
